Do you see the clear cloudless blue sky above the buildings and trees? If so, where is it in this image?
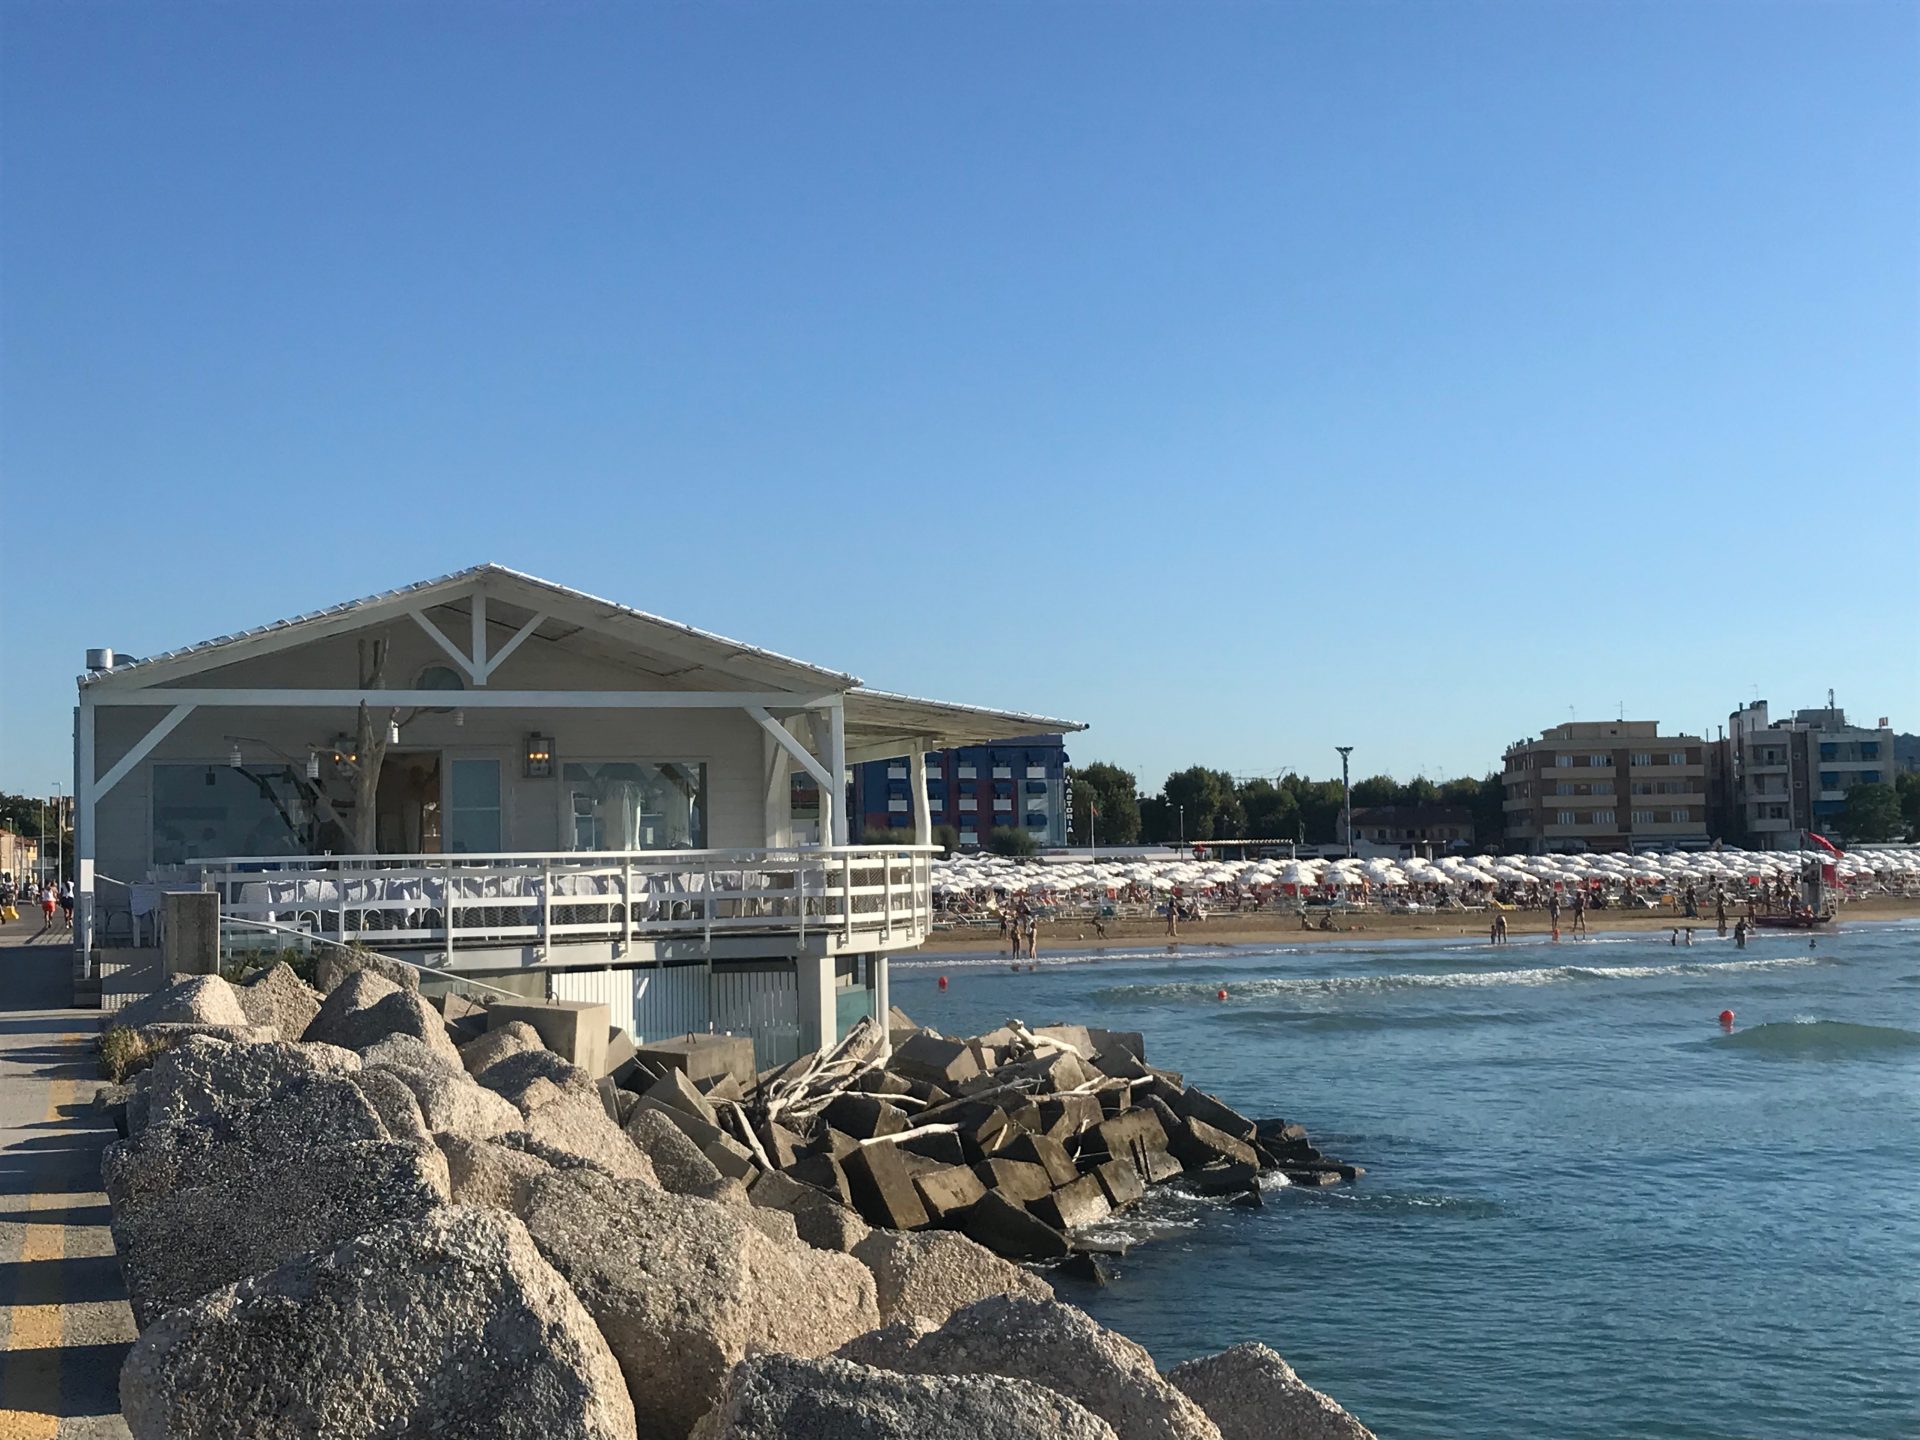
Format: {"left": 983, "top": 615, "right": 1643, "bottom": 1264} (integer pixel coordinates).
{"left": 0, "top": 0, "right": 1920, "bottom": 793}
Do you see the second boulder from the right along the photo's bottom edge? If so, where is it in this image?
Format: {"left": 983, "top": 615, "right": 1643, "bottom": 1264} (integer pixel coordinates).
{"left": 839, "top": 1296, "right": 1221, "bottom": 1440}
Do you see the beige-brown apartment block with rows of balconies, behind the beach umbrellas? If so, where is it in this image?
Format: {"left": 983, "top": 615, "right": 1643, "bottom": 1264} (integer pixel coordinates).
{"left": 1501, "top": 720, "right": 1707, "bottom": 854}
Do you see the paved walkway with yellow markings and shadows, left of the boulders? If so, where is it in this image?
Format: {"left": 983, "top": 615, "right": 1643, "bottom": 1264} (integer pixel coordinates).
{"left": 0, "top": 929, "right": 134, "bottom": 1440}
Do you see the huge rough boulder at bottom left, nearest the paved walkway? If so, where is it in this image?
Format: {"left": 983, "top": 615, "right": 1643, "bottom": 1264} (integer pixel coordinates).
{"left": 121, "top": 1208, "right": 634, "bottom": 1440}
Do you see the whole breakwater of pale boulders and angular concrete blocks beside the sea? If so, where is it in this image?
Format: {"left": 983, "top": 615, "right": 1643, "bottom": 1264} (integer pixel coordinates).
{"left": 102, "top": 962, "right": 1367, "bottom": 1440}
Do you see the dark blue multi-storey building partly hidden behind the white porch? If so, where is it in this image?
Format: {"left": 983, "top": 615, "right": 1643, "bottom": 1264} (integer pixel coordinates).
{"left": 849, "top": 735, "right": 1069, "bottom": 851}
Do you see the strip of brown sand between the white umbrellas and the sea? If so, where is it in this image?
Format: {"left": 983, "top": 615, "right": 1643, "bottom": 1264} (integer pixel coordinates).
{"left": 918, "top": 895, "right": 1920, "bottom": 958}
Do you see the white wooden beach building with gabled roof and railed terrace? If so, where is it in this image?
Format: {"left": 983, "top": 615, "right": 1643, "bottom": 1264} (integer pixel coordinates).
{"left": 75, "top": 564, "right": 1081, "bottom": 1064}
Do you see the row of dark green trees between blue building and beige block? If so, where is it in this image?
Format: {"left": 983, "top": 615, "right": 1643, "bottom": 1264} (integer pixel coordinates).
{"left": 1071, "top": 760, "right": 1505, "bottom": 845}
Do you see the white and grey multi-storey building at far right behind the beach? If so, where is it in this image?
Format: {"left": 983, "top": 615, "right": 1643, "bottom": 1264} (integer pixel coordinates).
{"left": 1718, "top": 701, "right": 1895, "bottom": 851}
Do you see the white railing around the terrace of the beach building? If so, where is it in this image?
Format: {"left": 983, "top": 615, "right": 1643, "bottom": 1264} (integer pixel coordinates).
{"left": 172, "top": 845, "right": 935, "bottom": 956}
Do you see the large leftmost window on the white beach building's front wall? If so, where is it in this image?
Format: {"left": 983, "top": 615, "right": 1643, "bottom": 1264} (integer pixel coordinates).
{"left": 154, "top": 764, "right": 336, "bottom": 866}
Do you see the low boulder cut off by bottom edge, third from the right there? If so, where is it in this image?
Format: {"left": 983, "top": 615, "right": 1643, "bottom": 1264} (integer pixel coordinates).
{"left": 691, "top": 1356, "right": 1114, "bottom": 1440}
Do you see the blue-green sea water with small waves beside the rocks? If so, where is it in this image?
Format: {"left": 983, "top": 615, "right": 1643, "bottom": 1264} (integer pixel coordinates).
{"left": 893, "top": 924, "right": 1920, "bottom": 1440}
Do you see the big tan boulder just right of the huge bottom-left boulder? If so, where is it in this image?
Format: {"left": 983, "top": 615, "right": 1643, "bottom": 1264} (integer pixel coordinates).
{"left": 526, "top": 1171, "right": 879, "bottom": 1436}
